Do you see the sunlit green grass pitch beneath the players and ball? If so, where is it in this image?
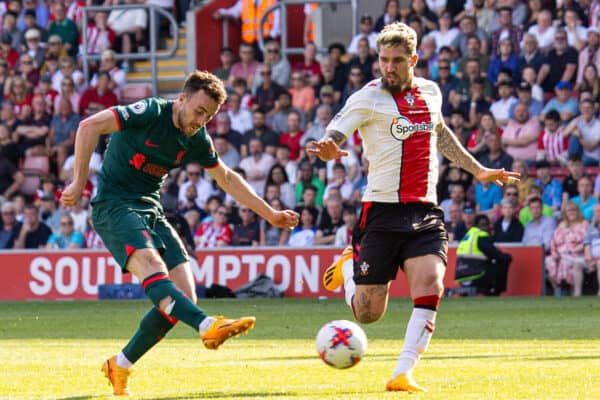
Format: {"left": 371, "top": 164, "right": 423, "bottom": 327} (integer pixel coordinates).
{"left": 0, "top": 297, "right": 600, "bottom": 400}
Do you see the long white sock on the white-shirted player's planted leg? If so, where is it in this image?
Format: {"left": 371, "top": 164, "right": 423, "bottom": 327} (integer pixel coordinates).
{"left": 392, "top": 308, "right": 437, "bottom": 378}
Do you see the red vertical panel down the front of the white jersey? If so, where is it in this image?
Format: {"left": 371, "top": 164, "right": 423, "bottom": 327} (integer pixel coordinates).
{"left": 393, "top": 87, "right": 432, "bottom": 203}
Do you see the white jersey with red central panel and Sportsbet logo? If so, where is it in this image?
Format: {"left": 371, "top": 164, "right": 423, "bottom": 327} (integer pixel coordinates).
{"left": 327, "top": 78, "right": 442, "bottom": 204}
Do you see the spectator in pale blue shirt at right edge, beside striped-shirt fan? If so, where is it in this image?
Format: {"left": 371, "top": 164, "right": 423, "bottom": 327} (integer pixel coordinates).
{"left": 565, "top": 100, "right": 600, "bottom": 166}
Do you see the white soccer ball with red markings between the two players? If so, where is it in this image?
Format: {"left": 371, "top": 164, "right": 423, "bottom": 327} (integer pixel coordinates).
{"left": 317, "top": 320, "right": 367, "bottom": 369}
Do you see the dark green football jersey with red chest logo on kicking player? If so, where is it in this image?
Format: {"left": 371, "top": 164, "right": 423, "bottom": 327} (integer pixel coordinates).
{"left": 94, "top": 97, "right": 218, "bottom": 205}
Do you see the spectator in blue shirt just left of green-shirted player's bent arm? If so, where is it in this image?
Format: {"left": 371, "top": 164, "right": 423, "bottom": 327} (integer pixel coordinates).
{"left": 47, "top": 99, "right": 80, "bottom": 172}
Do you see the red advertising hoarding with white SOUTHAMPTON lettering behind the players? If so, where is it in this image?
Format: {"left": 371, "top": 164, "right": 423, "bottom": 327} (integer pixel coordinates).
{"left": 0, "top": 246, "right": 543, "bottom": 300}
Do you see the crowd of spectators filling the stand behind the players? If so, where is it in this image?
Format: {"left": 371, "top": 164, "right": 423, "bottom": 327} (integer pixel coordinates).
{"left": 0, "top": 0, "right": 600, "bottom": 295}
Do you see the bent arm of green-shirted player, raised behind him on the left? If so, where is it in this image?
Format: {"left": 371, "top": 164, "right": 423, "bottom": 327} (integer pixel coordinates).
{"left": 61, "top": 109, "right": 119, "bottom": 207}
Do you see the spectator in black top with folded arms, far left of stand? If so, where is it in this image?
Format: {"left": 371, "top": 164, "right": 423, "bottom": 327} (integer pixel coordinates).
{"left": 13, "top": 95, "right": 52, "bottom": 156}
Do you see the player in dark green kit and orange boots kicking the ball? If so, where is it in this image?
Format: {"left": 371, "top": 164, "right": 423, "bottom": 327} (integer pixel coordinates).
{"left": 61, "top": 71, "right": 299, "bottom": 395}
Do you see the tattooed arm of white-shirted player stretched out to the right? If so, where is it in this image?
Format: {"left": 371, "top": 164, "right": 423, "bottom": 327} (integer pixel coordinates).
{"left": 436, "top": 122, "right": 521, "bottom": 186}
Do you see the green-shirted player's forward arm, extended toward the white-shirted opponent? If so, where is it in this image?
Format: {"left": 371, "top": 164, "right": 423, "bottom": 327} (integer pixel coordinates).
{"left": 207, "top": 161, "right": 300, "bottom": 229}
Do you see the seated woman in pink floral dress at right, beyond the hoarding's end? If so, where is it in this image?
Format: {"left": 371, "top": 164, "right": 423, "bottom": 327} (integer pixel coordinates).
{"left": 545, "top": 202, "right": 588, "bottom": 296}
